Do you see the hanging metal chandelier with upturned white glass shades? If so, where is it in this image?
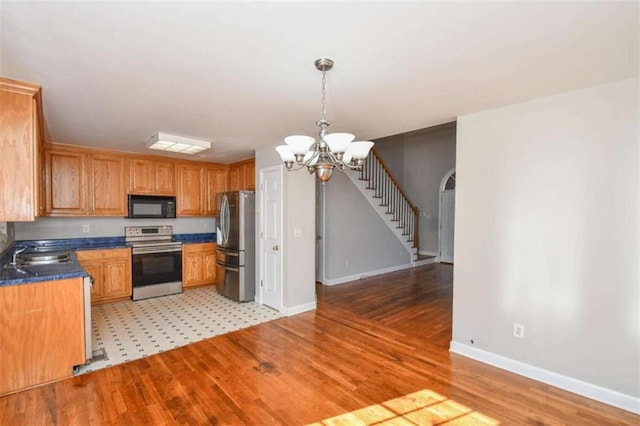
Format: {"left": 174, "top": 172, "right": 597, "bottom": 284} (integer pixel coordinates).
{"left": 276, "top": 59, "right": 373, "bottom": 184}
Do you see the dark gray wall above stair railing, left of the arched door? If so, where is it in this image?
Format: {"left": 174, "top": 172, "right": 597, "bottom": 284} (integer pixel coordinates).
{"left": 375, "top": 123, "right": 456, "bottom": 254}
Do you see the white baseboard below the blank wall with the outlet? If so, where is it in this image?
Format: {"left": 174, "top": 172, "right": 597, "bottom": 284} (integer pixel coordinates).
{"left": 449, "top": 342, "right": 640, "bottom": 414}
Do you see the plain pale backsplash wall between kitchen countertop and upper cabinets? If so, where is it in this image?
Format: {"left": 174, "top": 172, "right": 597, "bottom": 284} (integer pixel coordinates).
{"left": 10, "top": 217, "right": 215, "bottom": 241}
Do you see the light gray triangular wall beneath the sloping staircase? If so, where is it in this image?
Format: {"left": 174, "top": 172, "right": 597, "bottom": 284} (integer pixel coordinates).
{"left": 323, "top": 172, "right": 411, "bottom": 284}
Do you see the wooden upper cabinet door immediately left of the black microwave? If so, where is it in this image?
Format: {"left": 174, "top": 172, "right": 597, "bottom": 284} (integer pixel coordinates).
{"left": 90, "top": 154, "right": 126, "bottom": 216}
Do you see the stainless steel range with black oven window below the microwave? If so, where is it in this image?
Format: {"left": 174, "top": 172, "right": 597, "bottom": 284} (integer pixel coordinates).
{"left": 124, "top": 226, "right": 182, "bottom": 300}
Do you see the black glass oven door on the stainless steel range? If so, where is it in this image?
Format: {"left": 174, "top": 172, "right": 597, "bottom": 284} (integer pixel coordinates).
{"left": 131, "top": 247, "right": 182, "bottom": 287}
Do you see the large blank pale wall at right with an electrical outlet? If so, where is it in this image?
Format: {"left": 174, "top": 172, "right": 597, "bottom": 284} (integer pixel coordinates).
{"left": 453, "top": 79, "right": 640, "bottom": 400}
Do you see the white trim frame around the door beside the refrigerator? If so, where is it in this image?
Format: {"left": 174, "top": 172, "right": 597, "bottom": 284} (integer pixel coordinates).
{"left": 256, "top": 165, "right": 284, "bottom": 312}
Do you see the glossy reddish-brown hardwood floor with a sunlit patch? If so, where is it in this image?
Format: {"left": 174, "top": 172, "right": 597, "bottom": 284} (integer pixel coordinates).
{"left": 0, "top": 265, "right": 640, "bottom": 425}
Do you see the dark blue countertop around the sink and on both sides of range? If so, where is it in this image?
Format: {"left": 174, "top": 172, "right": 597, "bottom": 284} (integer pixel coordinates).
{"left": 0, "top": 233, "right": 216, "bottom": 287}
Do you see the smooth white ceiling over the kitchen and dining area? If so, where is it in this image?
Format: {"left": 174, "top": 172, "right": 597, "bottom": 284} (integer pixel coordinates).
{"left": 0, "top": 1, "right": 639, "bottom": 163}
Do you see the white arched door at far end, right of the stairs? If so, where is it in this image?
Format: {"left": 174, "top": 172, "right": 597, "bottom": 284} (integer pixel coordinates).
{"left": 438, "top": 168, "right": 456, "bottom": 263}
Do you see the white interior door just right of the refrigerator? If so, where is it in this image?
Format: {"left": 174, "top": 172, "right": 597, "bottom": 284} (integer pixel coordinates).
{"left": 260, "top": 167, "right": 282, "bottom": 310}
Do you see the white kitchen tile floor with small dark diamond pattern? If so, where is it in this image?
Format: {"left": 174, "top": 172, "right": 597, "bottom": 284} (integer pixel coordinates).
{"left": 78, "top": 287, "right": 281, "bottom": 374}
